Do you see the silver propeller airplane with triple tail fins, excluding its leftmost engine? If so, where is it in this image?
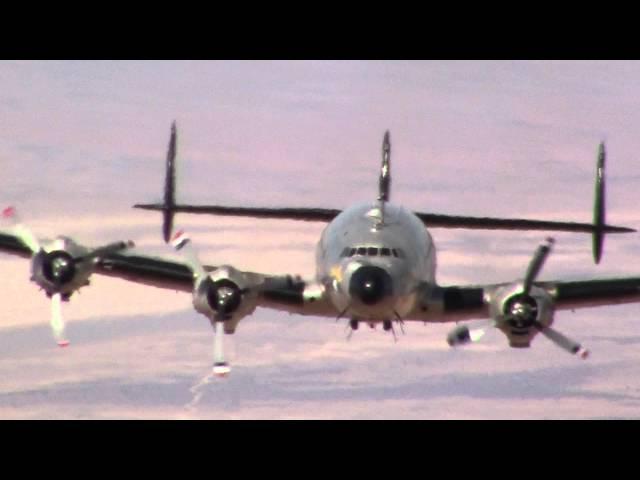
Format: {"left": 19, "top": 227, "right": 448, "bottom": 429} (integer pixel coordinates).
{"left": 0, "top": 122, "right": 640, "bottom": 376}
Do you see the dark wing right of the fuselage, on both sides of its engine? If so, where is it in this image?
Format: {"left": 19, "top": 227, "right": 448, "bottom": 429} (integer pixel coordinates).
{"left": 406, "top": 277, "right": 640, "bottom": 322}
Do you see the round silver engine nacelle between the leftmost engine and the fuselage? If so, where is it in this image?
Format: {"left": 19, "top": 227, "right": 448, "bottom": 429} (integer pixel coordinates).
{"left": 193, "top": 266, "right": 257, "bottom": 333}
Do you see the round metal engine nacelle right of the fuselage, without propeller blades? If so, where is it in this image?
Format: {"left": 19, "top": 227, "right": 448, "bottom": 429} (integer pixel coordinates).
{"left": 488, "top": 283, "right": 554, "bottom": 348}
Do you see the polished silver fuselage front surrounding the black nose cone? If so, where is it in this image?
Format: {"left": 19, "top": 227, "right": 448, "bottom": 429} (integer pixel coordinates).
{"left": 316, "top": 202, "right": 436, "bottom": 322}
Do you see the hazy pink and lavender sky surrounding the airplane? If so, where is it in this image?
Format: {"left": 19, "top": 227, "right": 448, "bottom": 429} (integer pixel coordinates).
{"left": 0, "top": 61, "right": 640, "bottom": 419}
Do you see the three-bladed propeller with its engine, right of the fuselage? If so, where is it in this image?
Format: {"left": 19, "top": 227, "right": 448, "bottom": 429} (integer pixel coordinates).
{"left": 447, "top": 238, "right": 589, "bottom": 359}
